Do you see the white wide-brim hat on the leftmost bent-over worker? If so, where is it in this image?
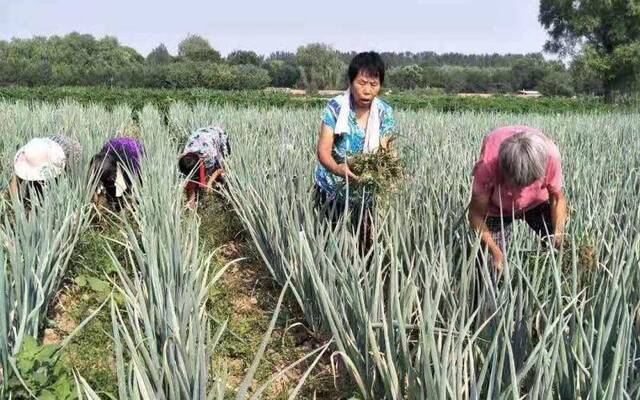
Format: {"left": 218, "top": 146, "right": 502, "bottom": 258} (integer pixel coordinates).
{"left": 13, "top": 138, "right": 67, "bottom": 181}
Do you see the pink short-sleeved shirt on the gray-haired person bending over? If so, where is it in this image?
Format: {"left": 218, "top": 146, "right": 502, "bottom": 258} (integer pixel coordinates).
{"left": 473, "top": 126, "right": 562, "bottom": 216}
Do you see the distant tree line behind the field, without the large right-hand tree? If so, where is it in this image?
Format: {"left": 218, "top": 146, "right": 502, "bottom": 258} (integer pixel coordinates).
{"left": 0, "top": 33, "right": 572, "bottom": 94}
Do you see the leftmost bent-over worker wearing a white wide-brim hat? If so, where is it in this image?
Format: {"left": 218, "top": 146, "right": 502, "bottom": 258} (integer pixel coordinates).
{"left": 9, "top": 138, "right": 67, "bottom": 208}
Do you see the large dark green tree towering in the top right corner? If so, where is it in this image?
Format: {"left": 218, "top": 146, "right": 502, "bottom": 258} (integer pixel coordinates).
{"left": 539, "top": 0, "right": 640, "bottom": 101}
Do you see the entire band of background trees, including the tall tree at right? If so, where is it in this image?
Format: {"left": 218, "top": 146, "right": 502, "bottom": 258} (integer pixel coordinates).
{"left": 0, "top": 0, "right": 640, "bottom": 99}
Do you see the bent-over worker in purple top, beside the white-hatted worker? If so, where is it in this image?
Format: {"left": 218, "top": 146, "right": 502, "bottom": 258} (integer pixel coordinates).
{"left": 90, "top": 137, "right": 144, "bottom": 212}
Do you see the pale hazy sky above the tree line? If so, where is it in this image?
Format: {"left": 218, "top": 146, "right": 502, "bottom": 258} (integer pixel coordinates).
{"left": 0, "top": 0, "right": 546, "bottom": 55}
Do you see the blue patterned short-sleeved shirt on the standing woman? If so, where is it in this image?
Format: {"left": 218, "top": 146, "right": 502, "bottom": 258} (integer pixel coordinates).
{"left": 316, "top": 95, "right": 396, "bottom": 198}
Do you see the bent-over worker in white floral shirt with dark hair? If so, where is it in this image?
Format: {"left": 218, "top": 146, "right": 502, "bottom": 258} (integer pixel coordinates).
{"left": 178, "top": 127, "right": 231, "bottom": 209}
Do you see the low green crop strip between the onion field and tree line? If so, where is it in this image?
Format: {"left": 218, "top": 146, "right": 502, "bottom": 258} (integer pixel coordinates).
{"left": 0, "top": 87, "right": 638, "bottom": 114}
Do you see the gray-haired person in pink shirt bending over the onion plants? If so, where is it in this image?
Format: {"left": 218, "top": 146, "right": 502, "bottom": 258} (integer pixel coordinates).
{"left": 469, "top": 126, "right": 567, "bottom": 270}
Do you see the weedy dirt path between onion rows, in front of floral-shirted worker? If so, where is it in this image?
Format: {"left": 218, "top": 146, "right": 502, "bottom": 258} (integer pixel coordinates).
{"left": 201, "top": 201, "right": 352, "bottom": 399}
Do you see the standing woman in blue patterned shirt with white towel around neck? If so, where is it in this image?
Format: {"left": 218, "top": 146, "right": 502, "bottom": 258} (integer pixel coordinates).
{"left": 315, "top": 52, "right": 396, "bottom": 211}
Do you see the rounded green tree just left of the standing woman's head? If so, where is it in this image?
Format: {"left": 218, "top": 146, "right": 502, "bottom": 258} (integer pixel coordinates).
{"left": 296, "top": 43, "right": 346, "bottom": 91}
